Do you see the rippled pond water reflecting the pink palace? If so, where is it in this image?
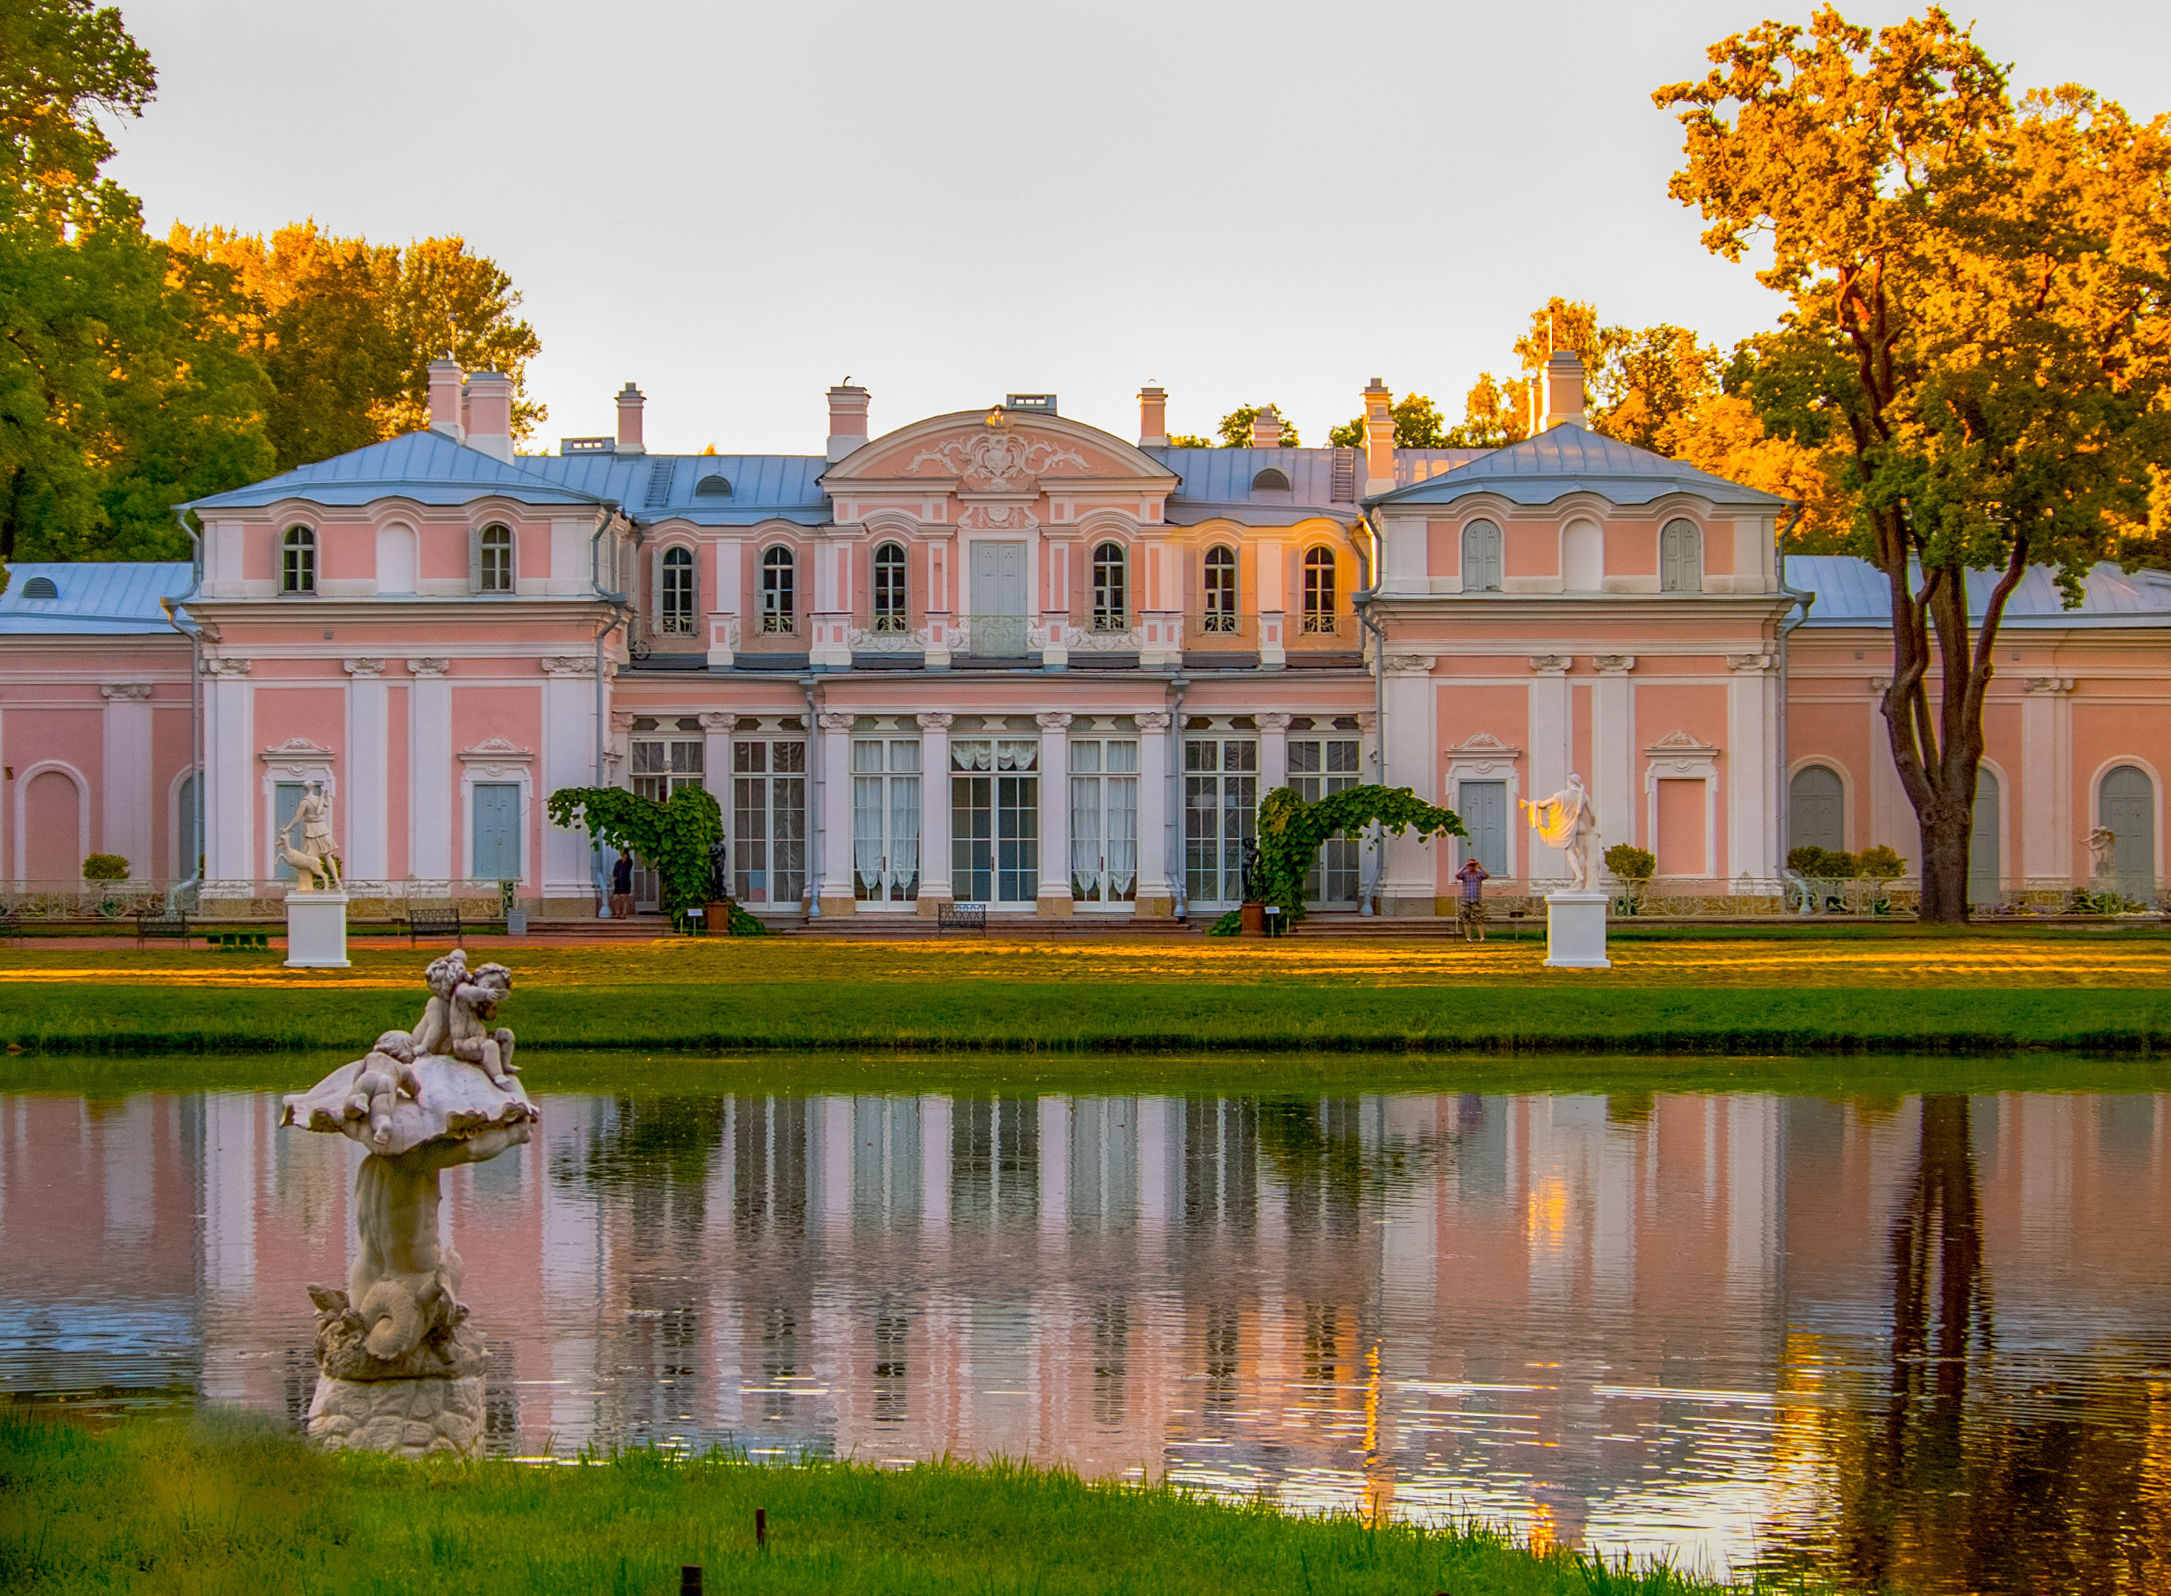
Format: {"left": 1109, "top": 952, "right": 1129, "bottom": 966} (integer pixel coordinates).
{"left": 0, "top": 1092, "right": 2171, "bottom": 1592}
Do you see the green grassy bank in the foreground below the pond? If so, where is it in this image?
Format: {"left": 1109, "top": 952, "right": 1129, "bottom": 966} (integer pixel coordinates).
{"left": 0, "top": 1416, "right": 1832, "bottom": 1596}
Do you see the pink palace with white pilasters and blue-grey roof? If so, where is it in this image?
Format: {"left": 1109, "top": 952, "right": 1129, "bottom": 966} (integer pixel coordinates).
{"left": 0, "top": 356, "right": 2171, "bottom": 921}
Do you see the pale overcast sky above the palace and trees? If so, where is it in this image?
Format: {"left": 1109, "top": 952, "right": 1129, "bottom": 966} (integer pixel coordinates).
{"left": 113, "top": 0, "right": 2171, "bottom": 454}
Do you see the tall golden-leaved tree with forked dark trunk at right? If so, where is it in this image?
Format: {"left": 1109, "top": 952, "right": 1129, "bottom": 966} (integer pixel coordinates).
{"left": 1654, "top": 7, "right": 2171, "bottom": 923}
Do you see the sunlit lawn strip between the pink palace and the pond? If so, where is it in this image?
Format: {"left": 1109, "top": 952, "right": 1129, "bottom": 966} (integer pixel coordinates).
{"left": 0, "top": 934, "right": 2171, "bottom": 1057}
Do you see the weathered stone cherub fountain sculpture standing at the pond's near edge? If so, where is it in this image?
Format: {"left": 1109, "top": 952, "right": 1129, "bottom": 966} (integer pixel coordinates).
{"left": 280, "top": 949, "right": 536, "bottom": 1457}
